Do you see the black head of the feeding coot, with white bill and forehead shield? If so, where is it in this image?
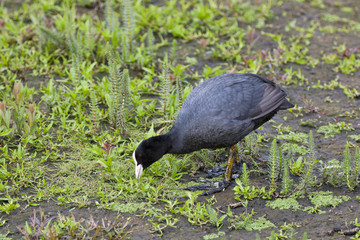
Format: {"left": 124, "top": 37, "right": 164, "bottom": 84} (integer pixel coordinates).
{"left": 133, "top": 135, "right": 167, "bottom": 179}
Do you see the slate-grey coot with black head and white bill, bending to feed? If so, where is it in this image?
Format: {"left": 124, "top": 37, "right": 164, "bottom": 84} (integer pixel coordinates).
{"left": 133, "top": 73, "right": 294, "bottom": 181}
